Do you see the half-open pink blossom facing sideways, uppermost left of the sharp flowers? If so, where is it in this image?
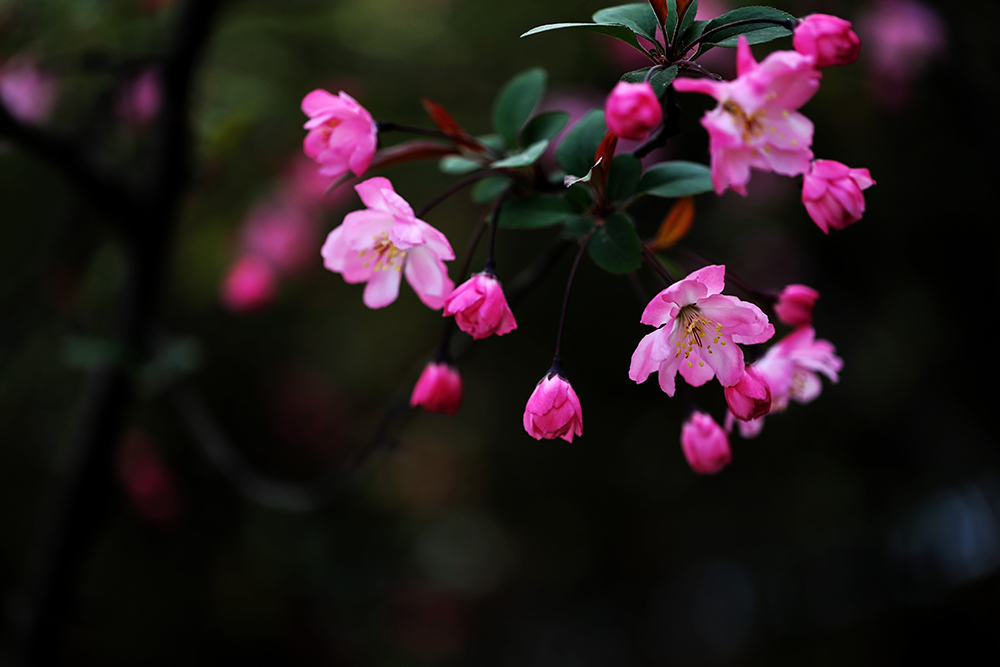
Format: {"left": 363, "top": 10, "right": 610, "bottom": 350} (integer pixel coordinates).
{"left": 302, "top": 90, "right": 378, "bottom": 178}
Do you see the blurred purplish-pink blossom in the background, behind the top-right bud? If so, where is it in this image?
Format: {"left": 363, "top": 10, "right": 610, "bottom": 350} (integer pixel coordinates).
{"left": 857, "top": 0, "right": 948, "bottom": 109}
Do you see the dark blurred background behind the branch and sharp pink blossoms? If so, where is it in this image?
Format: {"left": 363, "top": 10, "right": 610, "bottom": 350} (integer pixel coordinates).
{"left": 0, "top": 0, "right": 1000, "bottom": 667}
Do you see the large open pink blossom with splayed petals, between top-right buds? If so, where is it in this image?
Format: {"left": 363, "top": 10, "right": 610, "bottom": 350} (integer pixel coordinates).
{"left": 673, "top": 37, "right": 822, "bottom": 196}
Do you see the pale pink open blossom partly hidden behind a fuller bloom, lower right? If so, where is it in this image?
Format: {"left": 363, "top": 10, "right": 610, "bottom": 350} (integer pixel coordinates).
{"left": 727, "top": 326, "right": 844, "bottom": 438}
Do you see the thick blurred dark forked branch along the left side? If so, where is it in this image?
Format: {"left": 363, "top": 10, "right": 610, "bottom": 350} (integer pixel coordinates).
{"left": 0, "top": 0, "right": 223, "bottom": 665}
